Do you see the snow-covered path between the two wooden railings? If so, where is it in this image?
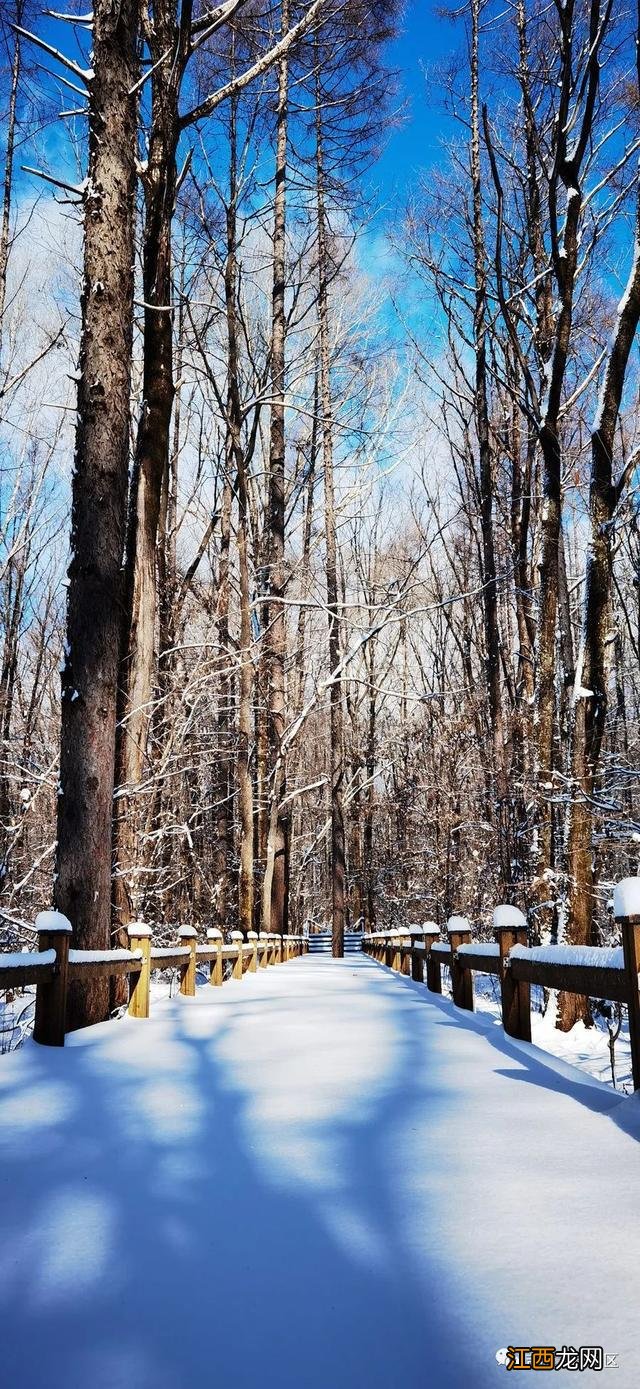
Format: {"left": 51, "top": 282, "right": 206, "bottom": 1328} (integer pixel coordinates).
{"left": 0, "top": 957, "right": 640, "bottom": 1389}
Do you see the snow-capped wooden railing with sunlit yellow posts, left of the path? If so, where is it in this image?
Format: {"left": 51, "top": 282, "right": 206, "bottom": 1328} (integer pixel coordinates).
{"left": 0, "top": 911, "right": 307, "bottom": 1046}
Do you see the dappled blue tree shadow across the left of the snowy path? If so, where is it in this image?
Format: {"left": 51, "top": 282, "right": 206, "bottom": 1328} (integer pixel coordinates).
{"left": 0, "top": 964, "right": 496, "bottom": 1389}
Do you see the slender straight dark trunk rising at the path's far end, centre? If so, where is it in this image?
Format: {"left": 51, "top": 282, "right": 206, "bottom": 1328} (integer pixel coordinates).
{"left": 315, "top": 79, "right": 346, "bottom": 958}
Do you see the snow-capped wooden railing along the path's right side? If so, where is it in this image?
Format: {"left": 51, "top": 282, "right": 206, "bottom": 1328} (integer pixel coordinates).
{"left": 362, "top": 878, "right": 640, "bottom": 1090}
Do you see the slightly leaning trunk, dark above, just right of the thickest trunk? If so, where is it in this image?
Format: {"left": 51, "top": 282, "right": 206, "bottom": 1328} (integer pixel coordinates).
{"left": 114, "top": 0, "right": 192, "bottom": 940}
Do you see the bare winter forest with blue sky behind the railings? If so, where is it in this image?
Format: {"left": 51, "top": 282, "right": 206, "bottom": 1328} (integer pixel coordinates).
{"left": 0, "top": 0, "right": 640, "bottom": 1031}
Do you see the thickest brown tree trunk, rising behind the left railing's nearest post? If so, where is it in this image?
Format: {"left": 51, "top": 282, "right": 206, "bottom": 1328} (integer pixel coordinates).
{"left": 54, "top": 0, "right": 139, "bottom": 1028}
